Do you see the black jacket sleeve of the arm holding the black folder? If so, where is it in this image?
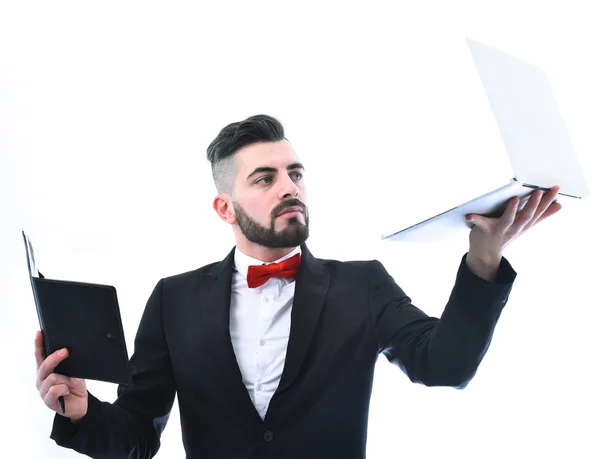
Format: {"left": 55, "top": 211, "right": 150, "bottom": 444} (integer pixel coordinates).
{"left": 50, "top": 279, "right": 175, "bottom": 459}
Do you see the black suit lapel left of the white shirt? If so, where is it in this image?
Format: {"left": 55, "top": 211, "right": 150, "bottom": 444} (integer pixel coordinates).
{"left": 200, "top": 248, "right": 262, "bottom": 422}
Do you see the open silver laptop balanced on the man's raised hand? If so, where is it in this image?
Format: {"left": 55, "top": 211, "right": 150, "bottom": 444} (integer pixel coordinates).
{"left": 382, "top": 38, "right": 589, "bottom": 241}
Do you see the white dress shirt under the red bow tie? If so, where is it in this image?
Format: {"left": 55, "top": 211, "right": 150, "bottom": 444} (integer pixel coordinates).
{"left": 229, "top": 247, "right": 301, "bottom": 419}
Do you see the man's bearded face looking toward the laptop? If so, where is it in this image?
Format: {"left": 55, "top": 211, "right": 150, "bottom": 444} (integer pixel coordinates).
{"left": 227, "top": 140, "right": 309, "bottom": 248}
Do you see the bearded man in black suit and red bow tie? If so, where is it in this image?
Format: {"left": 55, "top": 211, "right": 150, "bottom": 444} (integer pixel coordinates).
{"left": 35, "top": 115, "right": 560, "bottom": 459}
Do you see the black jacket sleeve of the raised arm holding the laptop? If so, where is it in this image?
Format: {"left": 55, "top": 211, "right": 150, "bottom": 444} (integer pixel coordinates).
{"left": 369, "top": 254, "right": 516, "bottom": 389}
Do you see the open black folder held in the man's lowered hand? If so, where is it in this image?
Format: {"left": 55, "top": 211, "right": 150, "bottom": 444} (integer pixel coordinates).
{"left": 22, "top": 231, "right": 131, "bottom": 385}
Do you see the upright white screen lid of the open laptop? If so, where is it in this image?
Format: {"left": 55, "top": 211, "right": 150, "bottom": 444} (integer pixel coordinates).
{"left": 467, "top": 38, "right": 589, "bottom": 197}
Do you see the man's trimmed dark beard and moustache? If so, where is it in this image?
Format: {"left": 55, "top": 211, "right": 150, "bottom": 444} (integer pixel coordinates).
{"left": 233, "top": 199, "right": 309, "bottom": 249}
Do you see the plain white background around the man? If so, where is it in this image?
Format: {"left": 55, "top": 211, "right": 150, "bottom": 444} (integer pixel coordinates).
{"left": 0, "top": 0, "right": 600, "bottom": 459}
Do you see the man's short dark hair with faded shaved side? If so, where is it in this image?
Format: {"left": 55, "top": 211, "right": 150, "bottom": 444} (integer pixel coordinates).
{"left": 206, "top": 115, "right": 287, "bottom": 193}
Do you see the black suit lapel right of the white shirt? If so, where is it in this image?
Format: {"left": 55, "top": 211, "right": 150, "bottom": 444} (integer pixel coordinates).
{"left": 275, "top": 245, "right": 329, "bottom": 395}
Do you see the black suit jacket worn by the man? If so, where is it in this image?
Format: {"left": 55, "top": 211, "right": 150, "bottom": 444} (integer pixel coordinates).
{"left": 51, "top": 245, "right": 516, "bottom": 459}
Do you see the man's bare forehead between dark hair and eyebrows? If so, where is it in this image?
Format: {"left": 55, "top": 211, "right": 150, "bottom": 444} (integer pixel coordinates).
{"left": 235, "top": 140, "right": 299, "bottom": 173}
